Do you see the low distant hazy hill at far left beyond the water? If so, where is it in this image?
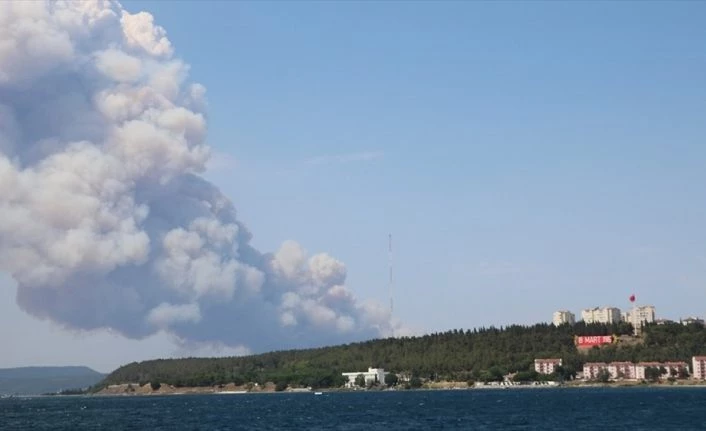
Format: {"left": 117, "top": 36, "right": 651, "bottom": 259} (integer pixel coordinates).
{"left": 0, "top": 367, "right": 105, "bottom": 395}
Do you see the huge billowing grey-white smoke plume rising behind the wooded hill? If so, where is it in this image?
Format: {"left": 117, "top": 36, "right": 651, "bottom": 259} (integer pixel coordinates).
{"left": 0, "top": 0, "right": 391, "bottom": 350}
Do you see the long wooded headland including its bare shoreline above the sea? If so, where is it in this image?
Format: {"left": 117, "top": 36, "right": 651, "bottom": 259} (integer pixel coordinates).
{"left": 92, "top": 322, "right": 706, "bottom": 393}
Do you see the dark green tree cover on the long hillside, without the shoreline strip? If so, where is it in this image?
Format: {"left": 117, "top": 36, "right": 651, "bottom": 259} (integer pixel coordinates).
{"left": 100, "top": 323, "right": 706, "bottom": 388}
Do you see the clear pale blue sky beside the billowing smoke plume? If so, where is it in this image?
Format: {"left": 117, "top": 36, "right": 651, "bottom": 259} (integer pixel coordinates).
{"left": 3, "top": 1, "right": 706, "bottom": 369}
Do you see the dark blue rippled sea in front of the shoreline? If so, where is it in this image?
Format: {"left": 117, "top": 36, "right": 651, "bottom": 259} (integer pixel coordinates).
{"left": 0, "top": 387, "right": 706, "bottom": 431}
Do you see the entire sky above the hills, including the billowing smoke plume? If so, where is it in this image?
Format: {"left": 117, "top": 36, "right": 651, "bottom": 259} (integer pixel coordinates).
{"left": 0, "top": 1, "right": 706, "bottom": 372}
